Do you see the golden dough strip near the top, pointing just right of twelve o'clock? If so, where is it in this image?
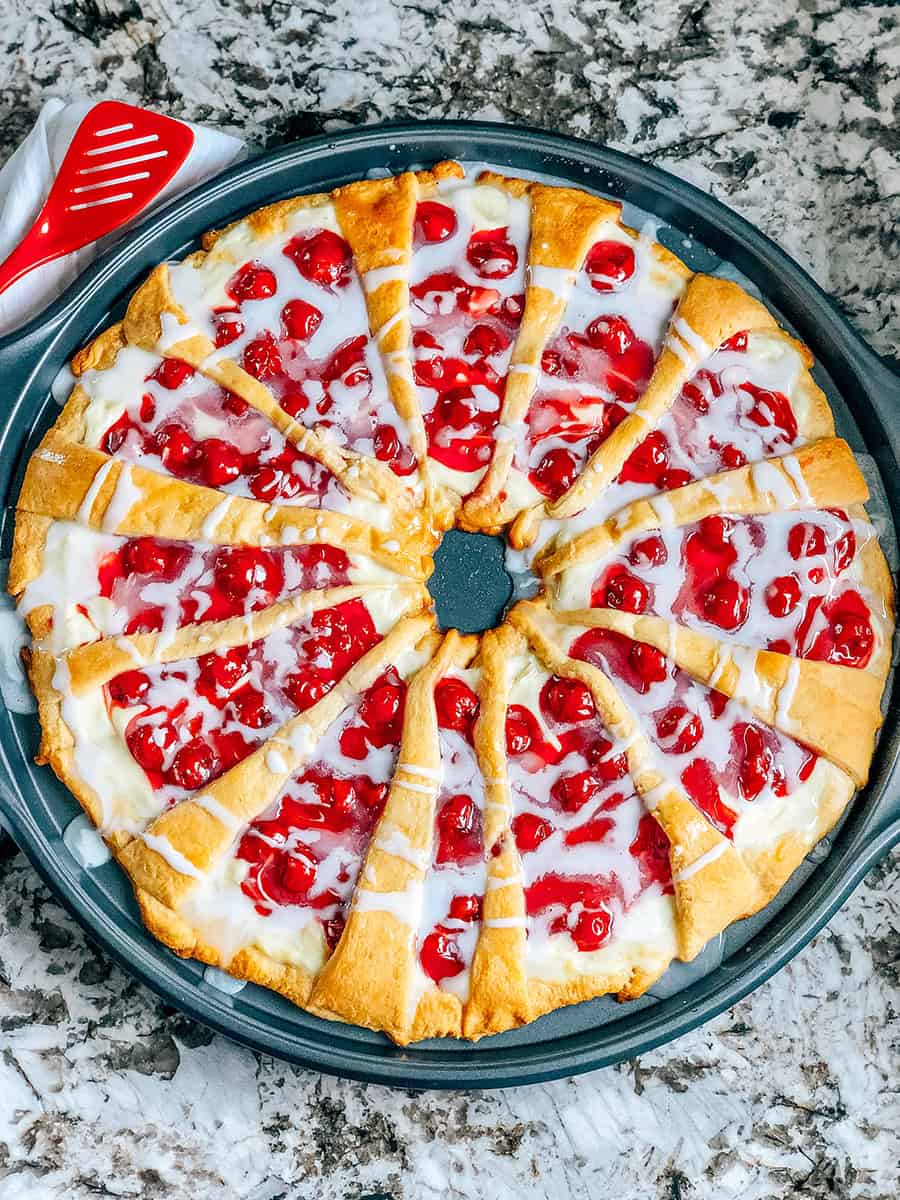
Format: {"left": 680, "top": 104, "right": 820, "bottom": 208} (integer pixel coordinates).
{"left": 463, "top": 184, "right": 690, "bottom": 533}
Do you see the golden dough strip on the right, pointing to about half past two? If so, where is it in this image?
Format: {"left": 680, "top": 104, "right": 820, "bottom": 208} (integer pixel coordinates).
{"left": 538, "top": 438, "right": 869, "bottom": 578}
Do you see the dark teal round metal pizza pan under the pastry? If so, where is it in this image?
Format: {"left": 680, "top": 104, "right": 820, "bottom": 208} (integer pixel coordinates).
{"left": 0, "top": 121, "right": 900, "bottom": 1088}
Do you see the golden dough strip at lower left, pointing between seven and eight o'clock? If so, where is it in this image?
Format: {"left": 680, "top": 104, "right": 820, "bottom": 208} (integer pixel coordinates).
{"left": 120, "top": 617, "right": 444, "bottom": 908}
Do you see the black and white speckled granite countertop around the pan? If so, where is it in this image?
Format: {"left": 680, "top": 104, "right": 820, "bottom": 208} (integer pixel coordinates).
{"left": 0, "top": 0, "right": 900, "bottom": 1200}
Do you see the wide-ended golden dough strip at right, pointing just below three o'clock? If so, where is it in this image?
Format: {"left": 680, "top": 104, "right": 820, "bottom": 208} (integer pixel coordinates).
{"left": 559, "top": 608, "right": 883, "bottom": 787}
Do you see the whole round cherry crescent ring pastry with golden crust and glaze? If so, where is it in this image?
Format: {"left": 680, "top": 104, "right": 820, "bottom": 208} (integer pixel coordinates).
{"left": 8, "top": 162, "right": 894, "bottom": 1044}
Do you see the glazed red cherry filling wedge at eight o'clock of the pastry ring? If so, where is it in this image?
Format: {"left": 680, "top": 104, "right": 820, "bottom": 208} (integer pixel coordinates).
{"left": 106, "top": 599, "right": 380, "bottom": 803}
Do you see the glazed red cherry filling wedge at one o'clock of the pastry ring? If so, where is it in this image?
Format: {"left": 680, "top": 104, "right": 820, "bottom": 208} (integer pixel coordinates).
{"left": 515, "top": 240, "right": 657, "bottom": 500}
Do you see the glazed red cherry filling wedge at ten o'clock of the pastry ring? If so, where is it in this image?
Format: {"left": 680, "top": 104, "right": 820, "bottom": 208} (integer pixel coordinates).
{"left": 100, "top": 359, "right": 340, "bottom": 506}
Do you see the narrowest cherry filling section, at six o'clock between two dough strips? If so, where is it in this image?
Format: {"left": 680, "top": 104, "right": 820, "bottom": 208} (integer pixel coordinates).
{"left": 419, "top": 674, "right": 486, "bottom": 986}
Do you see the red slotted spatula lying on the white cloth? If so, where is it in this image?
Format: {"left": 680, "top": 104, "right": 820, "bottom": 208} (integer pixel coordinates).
{"left": 0, "top": 100, "right": 193, "bottom": 292}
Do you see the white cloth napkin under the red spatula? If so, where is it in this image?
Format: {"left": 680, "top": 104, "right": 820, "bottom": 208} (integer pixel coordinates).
{"left": 0, "top": 100, "right": 245, "bottom": 335}
